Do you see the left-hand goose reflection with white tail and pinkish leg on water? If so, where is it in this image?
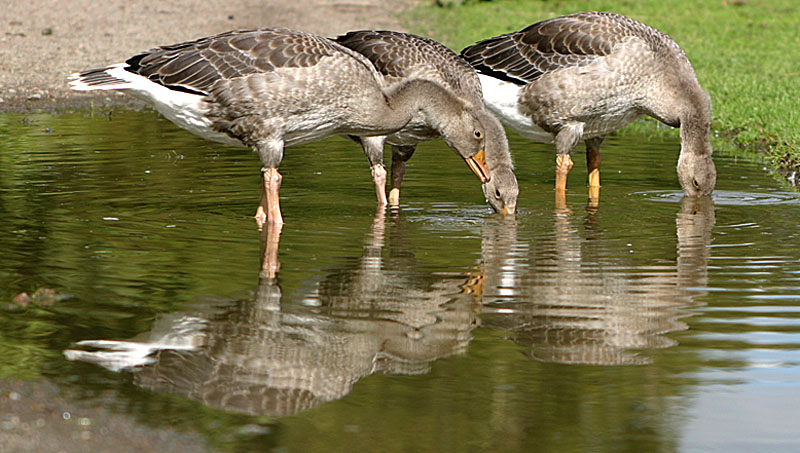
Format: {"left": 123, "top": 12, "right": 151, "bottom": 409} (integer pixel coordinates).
{"left": 65, "top": 212, "right": 477, "bottom": 416}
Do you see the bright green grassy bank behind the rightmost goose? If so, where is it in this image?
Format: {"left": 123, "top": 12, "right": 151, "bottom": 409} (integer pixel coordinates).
{"left": 404, "top": 0, "right": 800, "bottom": 180}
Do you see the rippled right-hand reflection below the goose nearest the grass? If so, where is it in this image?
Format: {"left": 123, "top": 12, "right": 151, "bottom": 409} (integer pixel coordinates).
{"left": 479, "top": 197, "right": 714, "bottom": 365}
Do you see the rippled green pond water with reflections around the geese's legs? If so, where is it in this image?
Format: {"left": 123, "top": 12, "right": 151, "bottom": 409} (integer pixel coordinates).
{"left": 0, "top": 110, "right": 800, "bottom": 452}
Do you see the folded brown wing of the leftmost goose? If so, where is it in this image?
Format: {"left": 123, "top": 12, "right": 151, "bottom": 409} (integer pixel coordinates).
{"left": 126, "top": 28, "right": 360, "bottom": 95}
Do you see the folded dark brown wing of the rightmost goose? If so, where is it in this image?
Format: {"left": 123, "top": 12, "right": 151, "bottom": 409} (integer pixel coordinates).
{"left": 461, "top": 12, "right": 656, "bottom": 85}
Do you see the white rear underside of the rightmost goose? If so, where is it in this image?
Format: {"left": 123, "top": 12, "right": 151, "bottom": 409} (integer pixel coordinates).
{"left": 479, "top": 74, "right": 553, "bottom": 143}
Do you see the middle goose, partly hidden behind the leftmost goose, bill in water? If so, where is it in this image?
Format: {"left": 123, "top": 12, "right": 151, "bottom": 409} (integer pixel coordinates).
{"left": 335, "top": 30, "right": 519, "bottom": 214}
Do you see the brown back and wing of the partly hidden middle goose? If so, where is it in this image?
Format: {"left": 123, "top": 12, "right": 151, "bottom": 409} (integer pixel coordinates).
{"left": 335, "top": 30, "right": 481, "bottom": 100}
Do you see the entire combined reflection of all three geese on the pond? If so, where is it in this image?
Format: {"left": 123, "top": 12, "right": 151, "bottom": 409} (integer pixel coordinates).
{"left": 65, "top": 198, "right": 714, "bottom": 416}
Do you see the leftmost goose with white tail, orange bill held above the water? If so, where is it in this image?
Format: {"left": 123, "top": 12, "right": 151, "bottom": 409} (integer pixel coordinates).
{"left": 70, "top": 28, "right": 490, "bottom": 227}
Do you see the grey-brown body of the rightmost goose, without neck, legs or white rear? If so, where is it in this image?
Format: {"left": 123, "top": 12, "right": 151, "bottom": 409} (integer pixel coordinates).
{"left": 461, "top": 12, "right": 702, "bottom": 142}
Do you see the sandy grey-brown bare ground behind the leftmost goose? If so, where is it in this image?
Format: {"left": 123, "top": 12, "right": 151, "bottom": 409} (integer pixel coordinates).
{"left": 0, "top": 0, "right": 413, "bottom": 112}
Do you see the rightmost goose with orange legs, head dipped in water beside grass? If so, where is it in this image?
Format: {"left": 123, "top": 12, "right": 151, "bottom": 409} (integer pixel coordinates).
{"left": 461, "top": 12, "right": 717, "bottom": 201}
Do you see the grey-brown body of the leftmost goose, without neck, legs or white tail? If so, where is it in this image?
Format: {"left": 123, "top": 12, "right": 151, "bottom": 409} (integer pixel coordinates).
{"left": 126, "top": 28, "right": 396, "bottom": 146}
